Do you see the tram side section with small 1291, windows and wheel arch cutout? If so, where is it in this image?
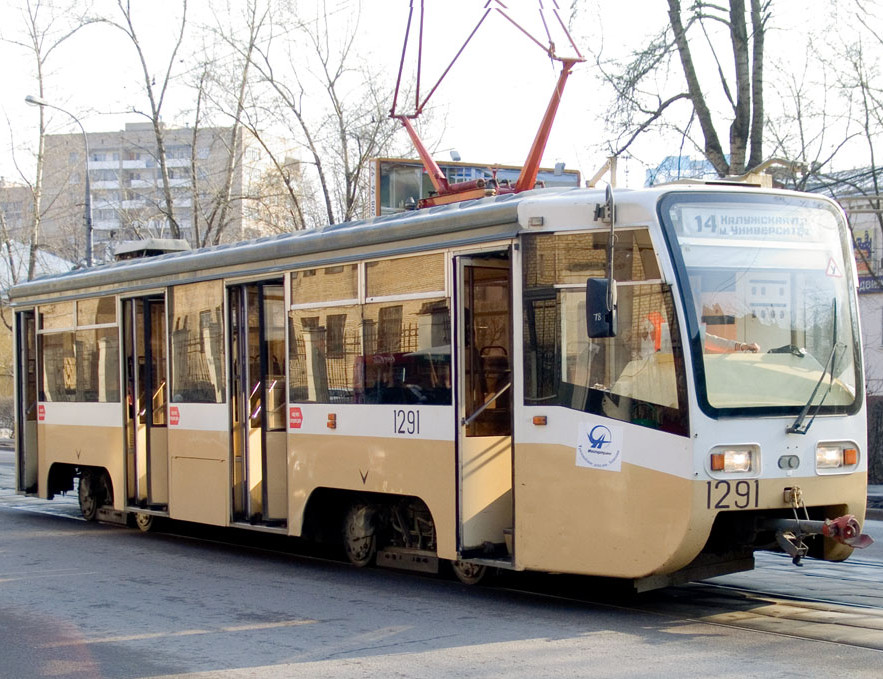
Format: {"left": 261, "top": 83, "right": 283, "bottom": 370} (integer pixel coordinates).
{"left": 287, "top": 252, "right": 456, "bottom": 558}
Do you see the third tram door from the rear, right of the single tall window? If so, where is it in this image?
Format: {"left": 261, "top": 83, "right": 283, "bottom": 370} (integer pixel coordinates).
{"left": 228, "top": 281, "right": 288, "bottom": 526}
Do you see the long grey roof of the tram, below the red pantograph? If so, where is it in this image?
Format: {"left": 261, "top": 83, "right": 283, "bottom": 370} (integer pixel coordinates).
{"left": 9, "top": 183, "right": 815, "bottom": 306}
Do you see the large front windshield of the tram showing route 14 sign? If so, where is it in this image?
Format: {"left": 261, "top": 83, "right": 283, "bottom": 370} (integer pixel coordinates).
{"left": 660, "top": 193, "right": 861, "bottom": 414}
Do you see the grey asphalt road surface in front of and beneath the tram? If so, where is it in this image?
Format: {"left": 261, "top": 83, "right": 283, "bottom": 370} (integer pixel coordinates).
{"left": 0, "top": 444, "right": 883, "bottom": 679}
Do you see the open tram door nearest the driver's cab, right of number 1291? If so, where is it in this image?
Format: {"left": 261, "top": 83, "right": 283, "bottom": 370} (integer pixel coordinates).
{"left": 456, "top": 253, "right": 513, "bottom": 559}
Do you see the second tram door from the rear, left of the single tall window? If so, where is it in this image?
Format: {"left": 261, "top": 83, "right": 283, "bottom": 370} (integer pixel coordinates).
{"left": 123, "top": 295, "right": 169, "bottom": 511}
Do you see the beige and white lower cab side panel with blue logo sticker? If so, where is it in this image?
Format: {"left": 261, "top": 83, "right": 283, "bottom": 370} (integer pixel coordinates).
{"left": 515, "top": 420, "right": 700, "bottom": 578}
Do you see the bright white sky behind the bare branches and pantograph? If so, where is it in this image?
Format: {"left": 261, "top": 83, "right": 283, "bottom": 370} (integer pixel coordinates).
{"left": 0, "top": 0, "right": 880, "bottom": 191}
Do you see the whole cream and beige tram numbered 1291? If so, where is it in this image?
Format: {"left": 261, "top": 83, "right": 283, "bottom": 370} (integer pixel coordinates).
{"left": 10, "top": 184, "right": 867, "bottom": 589}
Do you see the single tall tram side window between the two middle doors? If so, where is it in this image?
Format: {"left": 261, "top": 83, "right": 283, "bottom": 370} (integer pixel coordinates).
{"left": 170, "top": 281, "right": 226, "bottom": 403}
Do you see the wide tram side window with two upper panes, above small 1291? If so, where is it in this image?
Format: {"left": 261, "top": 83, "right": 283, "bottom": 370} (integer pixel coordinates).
{"left": 289, "top": 254, "right": 451, "bottom": 405}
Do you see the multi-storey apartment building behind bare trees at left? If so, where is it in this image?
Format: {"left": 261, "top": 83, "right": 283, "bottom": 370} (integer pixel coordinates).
{"left": 42, "top": 122, "right": 292, "bottom": 263}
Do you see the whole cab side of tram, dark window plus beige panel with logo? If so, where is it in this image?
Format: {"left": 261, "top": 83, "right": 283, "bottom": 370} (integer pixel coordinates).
{"left": 514, "top": 227, "right": 713, "bottom": 578}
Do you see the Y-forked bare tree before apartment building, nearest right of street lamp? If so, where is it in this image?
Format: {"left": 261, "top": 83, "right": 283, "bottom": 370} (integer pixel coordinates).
{"left": 103, "top": 0, "right": 187, "bottom": 238}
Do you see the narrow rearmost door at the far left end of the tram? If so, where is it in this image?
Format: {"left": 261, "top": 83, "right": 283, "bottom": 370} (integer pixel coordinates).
{"left": 15, "top": 311, "right": 38, "bottom": 493}
